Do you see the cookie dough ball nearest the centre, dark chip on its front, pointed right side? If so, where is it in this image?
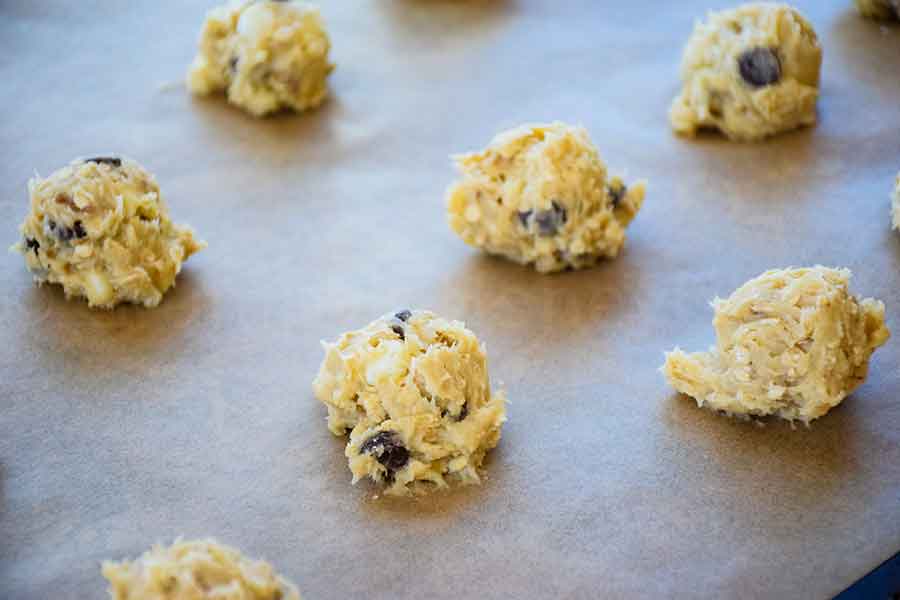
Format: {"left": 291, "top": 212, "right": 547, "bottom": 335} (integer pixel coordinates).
{"left": 447, "top": 122, "right": 646, "bottom": 273}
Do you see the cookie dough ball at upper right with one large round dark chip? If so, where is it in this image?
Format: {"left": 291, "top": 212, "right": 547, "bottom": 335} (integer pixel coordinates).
{"left": 669, "top": 3, "right": 822, "bottom": 141}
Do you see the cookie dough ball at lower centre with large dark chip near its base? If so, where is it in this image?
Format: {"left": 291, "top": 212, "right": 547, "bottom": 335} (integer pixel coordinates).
{"left": 313, "top": 310, "right": 506, "bottom": 494}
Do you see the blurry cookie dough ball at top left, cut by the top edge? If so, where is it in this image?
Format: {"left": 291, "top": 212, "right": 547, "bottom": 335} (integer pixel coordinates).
{"left": 188, "top": 0, "right": 334, "bottom": 117}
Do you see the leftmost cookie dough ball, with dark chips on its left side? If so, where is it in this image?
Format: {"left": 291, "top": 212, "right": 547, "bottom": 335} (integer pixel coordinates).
{"left": 12, "top": 157, "right": 206, "bottom": 308}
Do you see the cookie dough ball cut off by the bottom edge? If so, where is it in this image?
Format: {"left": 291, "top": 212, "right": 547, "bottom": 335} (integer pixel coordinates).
{"left": 103, "top": 540, "right": 300, "bottom": 600}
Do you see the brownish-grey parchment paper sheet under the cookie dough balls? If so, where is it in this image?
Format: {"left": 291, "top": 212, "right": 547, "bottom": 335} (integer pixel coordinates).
{"left": 0, "top": 0, "right": 900, "bottom": 599}
